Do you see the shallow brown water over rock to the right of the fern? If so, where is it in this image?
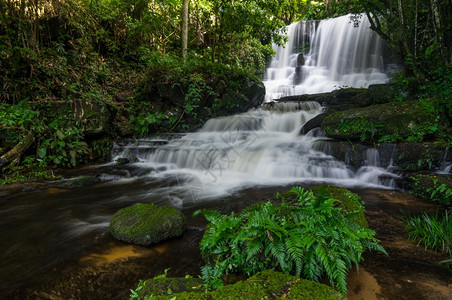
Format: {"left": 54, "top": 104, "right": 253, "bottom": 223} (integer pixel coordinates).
{"left": 348, "top": 190, "right": 452, "bottom": 300}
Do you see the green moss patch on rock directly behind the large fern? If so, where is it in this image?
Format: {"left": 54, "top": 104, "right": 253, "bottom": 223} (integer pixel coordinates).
{"left": 310, "top": 185, "right": 368, "bottom": 228}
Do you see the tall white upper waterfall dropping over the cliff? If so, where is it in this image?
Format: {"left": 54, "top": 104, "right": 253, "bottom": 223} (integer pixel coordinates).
{"left": 264, "top": 15, "right": 395, "bottom": 102}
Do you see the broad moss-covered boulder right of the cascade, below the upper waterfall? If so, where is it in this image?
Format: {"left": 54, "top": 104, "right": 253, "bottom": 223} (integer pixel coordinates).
{"left": 322, "top": 100, "right": 438, "bottom": 143}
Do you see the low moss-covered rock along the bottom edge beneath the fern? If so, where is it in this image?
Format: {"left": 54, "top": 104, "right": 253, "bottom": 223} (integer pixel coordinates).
{"left": 138, "top": 270, "right": 346, "bottom": 300}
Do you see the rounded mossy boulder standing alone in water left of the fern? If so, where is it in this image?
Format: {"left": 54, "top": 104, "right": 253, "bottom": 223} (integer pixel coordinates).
{"left": 110, "top": 203, "right": 185, "bottom": 246}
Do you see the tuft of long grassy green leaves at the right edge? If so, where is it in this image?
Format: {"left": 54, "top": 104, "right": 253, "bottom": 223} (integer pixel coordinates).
{"left": 405, "top": 211, "right": 452, "bottom": 256}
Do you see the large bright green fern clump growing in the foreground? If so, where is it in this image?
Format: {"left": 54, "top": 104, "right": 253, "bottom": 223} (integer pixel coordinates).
{"left": 195, "top": 187, "right": 386, "bottom": 293}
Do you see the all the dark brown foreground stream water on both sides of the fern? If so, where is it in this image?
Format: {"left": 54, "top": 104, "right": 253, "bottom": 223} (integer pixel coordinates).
{"left": 0, "top": 182, "right": 452, "bottom": 300}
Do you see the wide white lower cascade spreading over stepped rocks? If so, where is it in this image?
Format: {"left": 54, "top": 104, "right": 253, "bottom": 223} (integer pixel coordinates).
{"left": 113, "top": 102, "right": 396, "bottom": 204}
